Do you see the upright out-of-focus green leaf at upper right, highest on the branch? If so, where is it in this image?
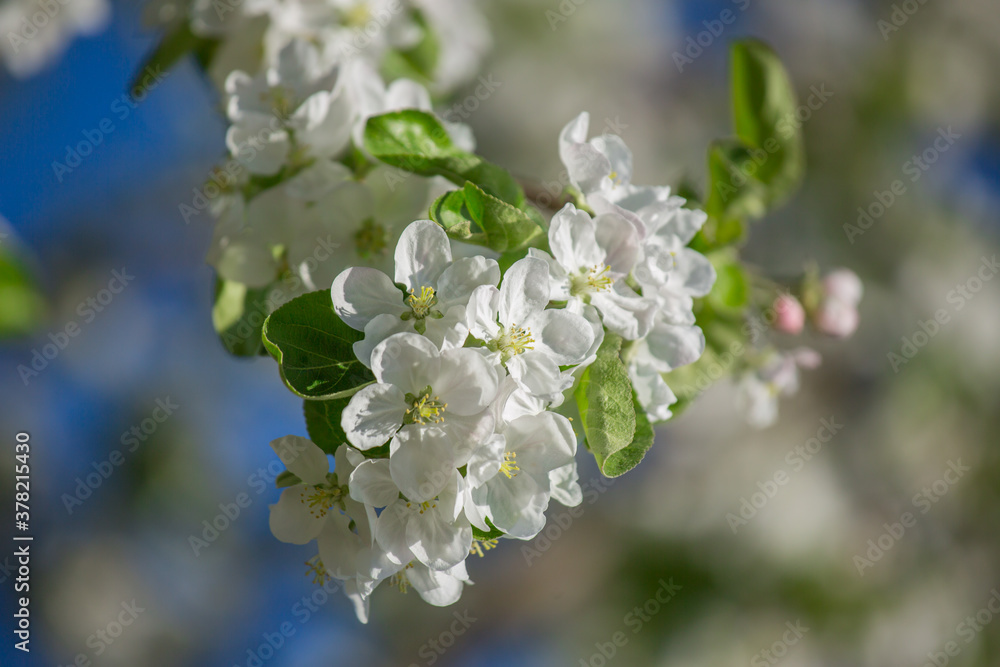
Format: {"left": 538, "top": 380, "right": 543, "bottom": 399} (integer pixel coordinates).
{"left": 732, "top": 40, "right": 805, "bottom": 207}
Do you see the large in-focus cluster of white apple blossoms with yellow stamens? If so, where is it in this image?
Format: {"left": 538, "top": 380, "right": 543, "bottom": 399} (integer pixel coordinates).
{"left": 262, "top": 115, "right": 715, "bottom": 619}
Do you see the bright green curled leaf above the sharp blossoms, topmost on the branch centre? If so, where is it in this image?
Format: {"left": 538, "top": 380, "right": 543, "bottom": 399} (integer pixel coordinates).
{"left": 365, "top": 109, "right": 525, "bottom": 208}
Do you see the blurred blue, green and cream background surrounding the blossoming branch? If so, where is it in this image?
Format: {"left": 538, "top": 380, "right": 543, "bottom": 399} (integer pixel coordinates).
{"left": 0, "top": 0, "right": 1000, "bottom": 667}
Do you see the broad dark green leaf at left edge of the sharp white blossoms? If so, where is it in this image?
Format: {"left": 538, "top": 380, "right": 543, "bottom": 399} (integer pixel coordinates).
{"left": 262, "top": 290, "right": 375, "bottom": 400}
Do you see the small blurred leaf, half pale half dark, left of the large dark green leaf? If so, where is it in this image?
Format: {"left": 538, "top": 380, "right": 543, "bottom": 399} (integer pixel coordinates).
{"left": 212, "top": 278, "right": 270, "bottom": 357}
